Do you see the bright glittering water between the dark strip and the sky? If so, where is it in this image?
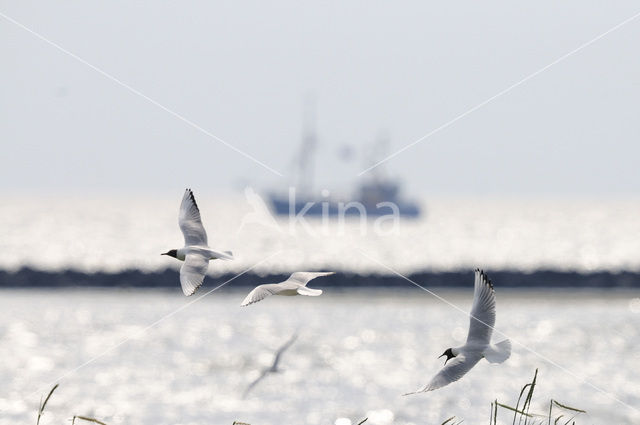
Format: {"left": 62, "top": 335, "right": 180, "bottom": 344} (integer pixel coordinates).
{"left": 0, "top": 195, "right": 640, "bottom": 275}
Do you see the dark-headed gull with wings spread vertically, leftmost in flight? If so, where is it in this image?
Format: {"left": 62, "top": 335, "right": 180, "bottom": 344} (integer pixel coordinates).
{"left": 162, "top": 189, "right": 233, "bottom": 296}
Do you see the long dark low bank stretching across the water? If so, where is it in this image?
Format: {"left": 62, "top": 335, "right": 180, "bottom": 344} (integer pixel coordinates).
{"left": 0, "top": 268, "right": 640, "bottom": 288}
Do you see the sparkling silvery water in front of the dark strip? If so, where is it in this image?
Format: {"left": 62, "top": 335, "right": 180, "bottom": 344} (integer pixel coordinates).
{"left": 0, "top": 281, "right": 640, "bottom": 425}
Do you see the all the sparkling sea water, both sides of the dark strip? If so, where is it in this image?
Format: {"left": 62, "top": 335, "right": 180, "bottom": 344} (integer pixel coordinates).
{"left": 0, "top": 197, "right": 640, "bottom": 425}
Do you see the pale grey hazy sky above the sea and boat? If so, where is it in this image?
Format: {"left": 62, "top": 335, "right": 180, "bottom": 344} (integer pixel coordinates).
{"left": 0, "top": 1, "right": 640, "bottom": 197}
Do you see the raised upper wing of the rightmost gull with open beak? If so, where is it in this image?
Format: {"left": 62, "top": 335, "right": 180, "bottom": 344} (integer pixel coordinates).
{"left": 467, "top": 269, "right": 496, "bottom": 344}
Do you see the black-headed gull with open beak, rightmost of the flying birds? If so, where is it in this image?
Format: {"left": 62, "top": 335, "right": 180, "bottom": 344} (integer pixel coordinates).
{"left": 405, "top": 269, "right": 511, "bottom": 395}
